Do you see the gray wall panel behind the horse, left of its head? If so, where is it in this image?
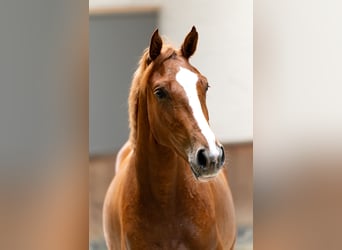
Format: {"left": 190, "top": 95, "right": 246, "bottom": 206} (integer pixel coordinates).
{"left": 89, "top": 12, "right": 157, "bottom": 154}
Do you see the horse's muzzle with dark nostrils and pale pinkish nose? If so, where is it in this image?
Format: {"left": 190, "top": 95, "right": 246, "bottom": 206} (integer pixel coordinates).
{"left": 189, "top": 145, "right": 225, "bottom": 181}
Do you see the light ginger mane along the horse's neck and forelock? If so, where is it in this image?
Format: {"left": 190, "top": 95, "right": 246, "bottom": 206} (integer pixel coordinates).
{"left": 128, "top": 45, "right": 176, "bottom": 149}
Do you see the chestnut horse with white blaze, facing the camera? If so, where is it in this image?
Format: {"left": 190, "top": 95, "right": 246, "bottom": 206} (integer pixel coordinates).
{"left": 103, "top": 27, "right": 236, "bottom": 250}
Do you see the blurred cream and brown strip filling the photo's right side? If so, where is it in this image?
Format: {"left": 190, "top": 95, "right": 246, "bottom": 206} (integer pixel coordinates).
{"left": 253, "top": 0, "right": 342, "bottom": 250}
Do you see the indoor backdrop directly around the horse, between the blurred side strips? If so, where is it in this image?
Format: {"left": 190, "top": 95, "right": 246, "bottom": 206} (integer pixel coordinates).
{"left": 89, "top": 0, "right": 253, "bottom": 250}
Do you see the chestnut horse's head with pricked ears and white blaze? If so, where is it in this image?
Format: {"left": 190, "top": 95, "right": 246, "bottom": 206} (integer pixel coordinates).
{"left": 135, "top": 27, "right": 225, "bottom": 181}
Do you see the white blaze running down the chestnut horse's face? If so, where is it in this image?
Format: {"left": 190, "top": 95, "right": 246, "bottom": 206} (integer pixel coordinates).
{"left": 176, "top": 67, "right": 219, "bottom": 157}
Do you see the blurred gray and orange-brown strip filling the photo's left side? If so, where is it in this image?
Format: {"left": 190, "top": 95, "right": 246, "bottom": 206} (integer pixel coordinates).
{"left": 0, "top": 0, "right": 89, "bottom": 250}
